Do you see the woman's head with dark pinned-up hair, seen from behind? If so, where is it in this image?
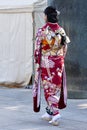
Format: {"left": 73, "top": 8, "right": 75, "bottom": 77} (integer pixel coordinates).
{"left": 44, "top": 6, "right": 58, "bottom": 23}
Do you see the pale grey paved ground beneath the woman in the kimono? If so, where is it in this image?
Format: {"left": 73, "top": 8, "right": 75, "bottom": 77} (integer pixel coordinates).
{"left": 0, "top": 88, "right": 87, "bottom": 130}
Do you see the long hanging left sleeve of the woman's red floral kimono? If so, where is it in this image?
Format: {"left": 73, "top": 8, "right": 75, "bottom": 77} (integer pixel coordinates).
{"left": 33, "top": 29, "right": 42, "bottom": 112}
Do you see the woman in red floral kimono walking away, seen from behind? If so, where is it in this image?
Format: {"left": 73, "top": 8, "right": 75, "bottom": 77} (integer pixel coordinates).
{"left": 34, "top": 6, "right": 69, "bottom": 125}
